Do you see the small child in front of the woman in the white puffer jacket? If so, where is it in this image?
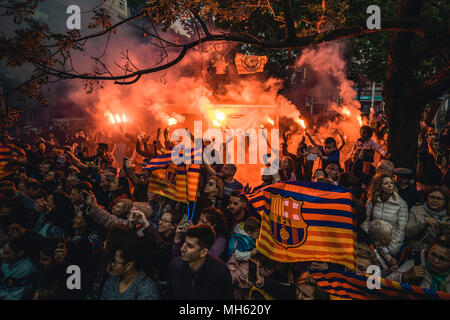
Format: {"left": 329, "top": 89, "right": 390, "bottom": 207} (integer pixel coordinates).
{"left": 369, "top": 219, "right": 399, "bottom": 277}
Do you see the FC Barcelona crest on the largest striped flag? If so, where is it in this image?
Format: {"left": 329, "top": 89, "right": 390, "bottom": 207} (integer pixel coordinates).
{"left": 269, "top": 195, "right": 308, "bottom": 248}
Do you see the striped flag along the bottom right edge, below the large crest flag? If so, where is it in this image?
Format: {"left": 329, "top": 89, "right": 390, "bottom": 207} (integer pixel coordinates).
{"left": 310, "top": 270, "right": 450, "bottom": 300}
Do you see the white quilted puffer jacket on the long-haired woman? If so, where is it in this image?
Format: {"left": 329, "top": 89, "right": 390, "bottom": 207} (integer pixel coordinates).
{"left": 362, "top": 192, "right": 408, "bottom": 255}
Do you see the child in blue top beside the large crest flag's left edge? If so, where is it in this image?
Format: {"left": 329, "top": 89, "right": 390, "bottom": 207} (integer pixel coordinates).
{"left": 227, "top": 217, "right": 261, "bottom": 261}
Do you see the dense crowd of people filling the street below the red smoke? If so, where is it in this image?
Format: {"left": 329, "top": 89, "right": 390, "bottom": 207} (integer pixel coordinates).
{"left": 0, "top": 114, "right": 450, "bottom": 300}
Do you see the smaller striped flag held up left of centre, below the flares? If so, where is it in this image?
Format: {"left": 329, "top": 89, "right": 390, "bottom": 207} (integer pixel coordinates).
{"left": 143, "top": 148, "right": 202, "bottom": 203}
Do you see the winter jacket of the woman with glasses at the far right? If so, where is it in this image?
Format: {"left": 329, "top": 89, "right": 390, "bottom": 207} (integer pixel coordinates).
{"left": 405, "top": 203, "right": 450, "bottom": 251}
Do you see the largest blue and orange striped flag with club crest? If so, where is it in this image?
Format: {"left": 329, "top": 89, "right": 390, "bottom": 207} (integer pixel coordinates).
{"left": 247, "top": 181, "right": 356, "bottom": 270}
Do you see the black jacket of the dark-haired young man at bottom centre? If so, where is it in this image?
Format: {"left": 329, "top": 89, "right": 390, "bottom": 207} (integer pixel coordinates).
{"left": 168, "top": 254, "right": 234, "bottom": 300}
